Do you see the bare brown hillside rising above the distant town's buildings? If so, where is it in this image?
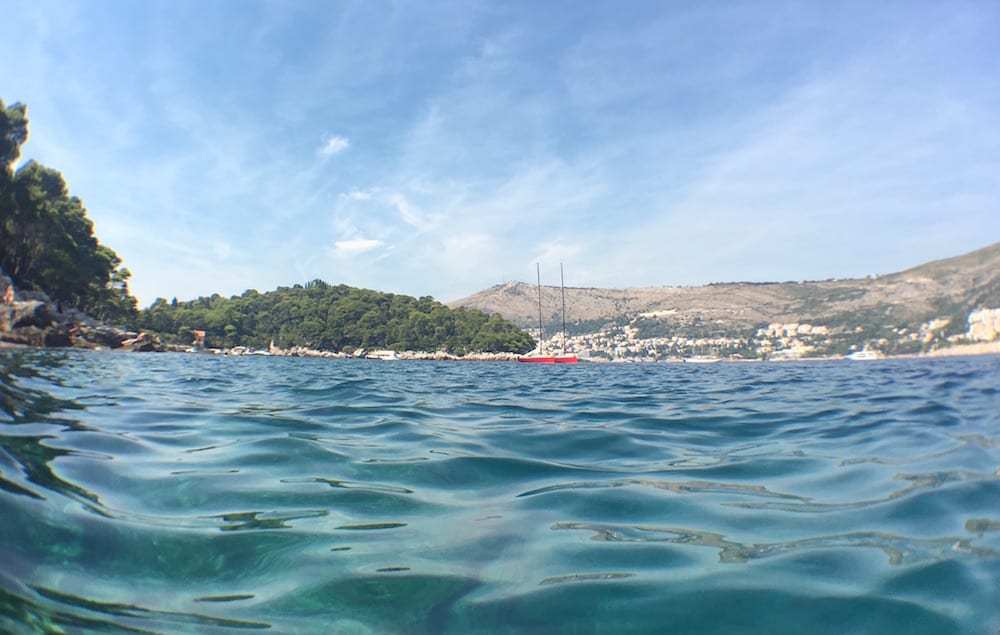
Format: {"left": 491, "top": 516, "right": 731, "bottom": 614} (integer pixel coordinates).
{"left": 451, "top": 243, "right": 1000, "bottom": 332}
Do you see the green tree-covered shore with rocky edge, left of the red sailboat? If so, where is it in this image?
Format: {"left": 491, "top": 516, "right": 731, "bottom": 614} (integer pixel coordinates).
{"left": 0, "top": 100, "right": 535, "bottom": 357}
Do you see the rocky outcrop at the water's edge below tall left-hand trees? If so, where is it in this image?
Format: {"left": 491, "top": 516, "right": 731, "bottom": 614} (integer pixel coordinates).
{"left": 0, "top": 264, "right": 163, "bottom": 352}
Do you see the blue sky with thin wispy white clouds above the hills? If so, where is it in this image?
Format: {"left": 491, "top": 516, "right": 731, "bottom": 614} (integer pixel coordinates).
{"left": 0, "top": 0, "right": 1000, "bottom": 305}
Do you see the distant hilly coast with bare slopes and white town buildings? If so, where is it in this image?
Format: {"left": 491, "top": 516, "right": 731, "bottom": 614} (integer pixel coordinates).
{"left": 451, "top": 243, "right": 1000, "bottom": 361}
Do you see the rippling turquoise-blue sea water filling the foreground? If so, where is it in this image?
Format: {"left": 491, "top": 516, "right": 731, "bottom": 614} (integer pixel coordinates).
{"left": 0, "top": 352, "right": 1000, "bottom": 635}
